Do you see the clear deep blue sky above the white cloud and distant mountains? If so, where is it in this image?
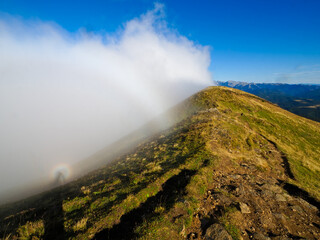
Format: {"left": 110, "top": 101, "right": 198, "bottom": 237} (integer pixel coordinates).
{"left": 0, "top": 0, "right": 320, "bottom": 83}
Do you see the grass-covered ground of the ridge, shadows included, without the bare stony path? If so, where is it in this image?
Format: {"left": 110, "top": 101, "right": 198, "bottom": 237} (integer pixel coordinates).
{"left": 0, "top": 87, "right": 320, "bottom": 239}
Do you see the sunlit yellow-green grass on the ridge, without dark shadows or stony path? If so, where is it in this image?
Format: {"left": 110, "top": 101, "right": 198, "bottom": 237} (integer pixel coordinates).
{"left": 1, "top": 87, "right": 320, "bottom": 239}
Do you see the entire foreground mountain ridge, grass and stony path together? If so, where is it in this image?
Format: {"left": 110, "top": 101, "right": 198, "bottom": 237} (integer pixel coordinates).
{"left": 0, "top": 87, "right": 320, "bottom": 239}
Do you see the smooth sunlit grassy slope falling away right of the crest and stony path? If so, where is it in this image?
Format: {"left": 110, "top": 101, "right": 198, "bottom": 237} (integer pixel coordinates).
{"left": 204, "top": 89, "right": 320, "bottom": 199}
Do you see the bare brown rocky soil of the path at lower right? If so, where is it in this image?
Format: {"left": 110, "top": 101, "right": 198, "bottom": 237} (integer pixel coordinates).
{"left": 187, "top": 136, "right": 320, "bottom": 240}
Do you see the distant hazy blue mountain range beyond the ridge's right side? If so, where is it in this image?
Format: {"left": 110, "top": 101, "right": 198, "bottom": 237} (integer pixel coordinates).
{"left": 217, "top": 81, "right": 320, "bottom": 122}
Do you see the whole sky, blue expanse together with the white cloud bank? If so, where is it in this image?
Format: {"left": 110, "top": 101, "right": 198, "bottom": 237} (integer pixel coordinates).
{"left": 0, "top": 0, "right": 320, "bottom": 200}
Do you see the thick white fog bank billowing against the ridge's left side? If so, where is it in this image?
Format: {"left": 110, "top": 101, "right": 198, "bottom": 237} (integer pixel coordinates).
{"left": 0, "top": 4, "right": 212, "bottom": 199}
